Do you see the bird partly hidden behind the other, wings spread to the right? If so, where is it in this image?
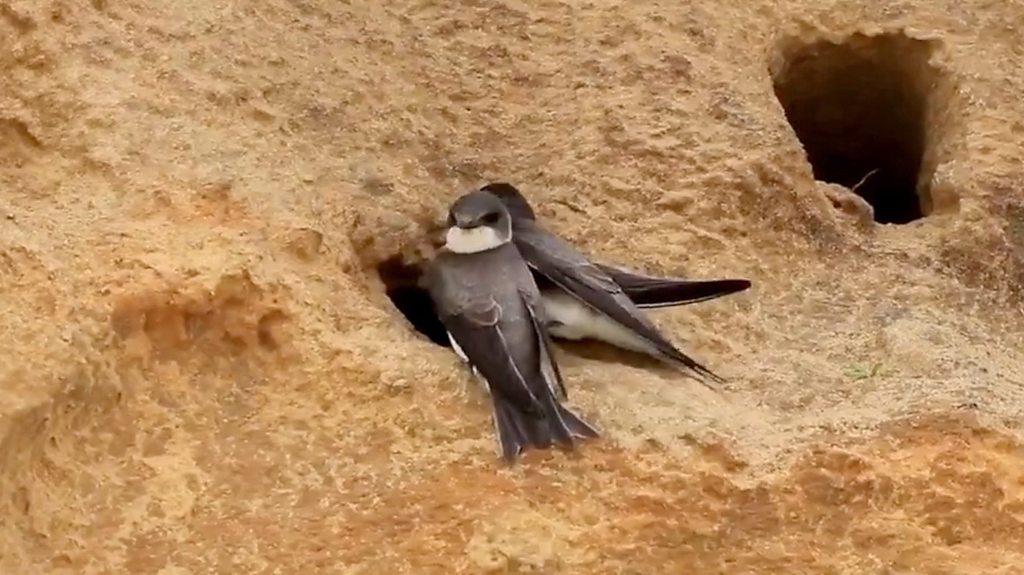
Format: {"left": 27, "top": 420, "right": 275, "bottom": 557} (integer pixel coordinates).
{"left": 479, "top": 182, "right": 750, "bottom": 388}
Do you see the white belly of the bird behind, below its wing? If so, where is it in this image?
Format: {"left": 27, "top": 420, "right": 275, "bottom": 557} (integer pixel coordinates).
{"left": 541, "top": 291, "right": 651, "bottom": 353}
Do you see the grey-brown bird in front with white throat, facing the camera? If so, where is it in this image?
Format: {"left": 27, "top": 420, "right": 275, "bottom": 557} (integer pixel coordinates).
{"left": 425, "top": 190, "right": 599, "bottom": 462}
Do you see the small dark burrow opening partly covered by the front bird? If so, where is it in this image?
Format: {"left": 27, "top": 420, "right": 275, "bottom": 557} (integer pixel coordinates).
{"left": 377, "top": 256, "right": 452, "bottom": 347}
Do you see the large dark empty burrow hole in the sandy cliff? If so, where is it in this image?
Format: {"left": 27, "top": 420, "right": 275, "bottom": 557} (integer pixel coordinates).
{"left": 770, "top": 33, "right": 947, "bottom": 224}
